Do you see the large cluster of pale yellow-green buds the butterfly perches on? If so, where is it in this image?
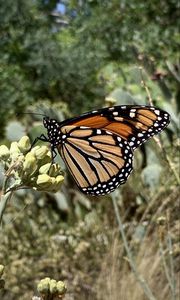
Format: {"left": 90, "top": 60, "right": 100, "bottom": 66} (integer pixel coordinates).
{"left": 0, "top": 136, "right": 64, "bottom": 192}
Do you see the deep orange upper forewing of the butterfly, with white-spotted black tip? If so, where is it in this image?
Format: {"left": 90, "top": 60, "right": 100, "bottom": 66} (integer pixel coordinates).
{"left": 67, "top": 105, "right": 170, "bottom": 150}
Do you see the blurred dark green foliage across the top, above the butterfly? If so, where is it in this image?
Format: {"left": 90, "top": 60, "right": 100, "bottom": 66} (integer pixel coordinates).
{"left": 0, "top": 0, "right": 179, "bottom": 135}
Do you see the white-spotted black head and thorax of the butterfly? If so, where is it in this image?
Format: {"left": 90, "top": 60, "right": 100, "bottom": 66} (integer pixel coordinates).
{"left": 43, "top": 117, "right": 61, "bottom": 146}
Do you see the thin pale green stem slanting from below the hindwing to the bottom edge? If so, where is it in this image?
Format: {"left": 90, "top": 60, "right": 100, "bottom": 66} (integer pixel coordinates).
{"left": 112, "top": 193, "right": 156, "bottom": 300}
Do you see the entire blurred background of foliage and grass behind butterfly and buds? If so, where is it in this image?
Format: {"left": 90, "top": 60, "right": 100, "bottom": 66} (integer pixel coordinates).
{"left": 0, "top": 0, "right": 180, "bottom": 300}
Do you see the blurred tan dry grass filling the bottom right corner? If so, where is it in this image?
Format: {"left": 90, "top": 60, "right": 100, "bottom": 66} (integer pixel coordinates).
{"left": 97, "top": 189, "right": 180, "bottom": 300}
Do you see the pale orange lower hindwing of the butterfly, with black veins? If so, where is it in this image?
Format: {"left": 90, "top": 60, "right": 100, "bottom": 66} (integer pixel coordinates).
{"left": 58, "top": 126, "right": 133, "bottom": 195}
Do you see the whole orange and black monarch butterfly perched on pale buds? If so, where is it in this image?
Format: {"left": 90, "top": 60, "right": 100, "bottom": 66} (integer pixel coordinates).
{"left": 33, "top": 105, "right": 170, "bottom": 196}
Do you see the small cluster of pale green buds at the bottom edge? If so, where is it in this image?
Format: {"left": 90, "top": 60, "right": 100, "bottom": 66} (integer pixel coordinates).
{"left": 37, "top": 277, "right": 67, "bottom": 300}
